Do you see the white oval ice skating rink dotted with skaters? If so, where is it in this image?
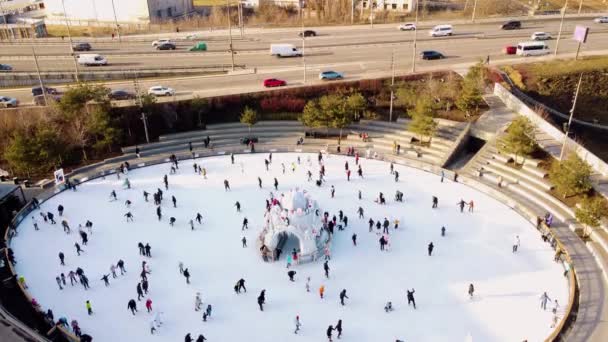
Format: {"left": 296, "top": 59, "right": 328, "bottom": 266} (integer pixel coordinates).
{"left": 12, "top": 154, "right": 568, "bottom": 342}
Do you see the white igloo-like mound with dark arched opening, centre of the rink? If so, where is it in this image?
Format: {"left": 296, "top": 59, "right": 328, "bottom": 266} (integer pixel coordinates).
{"left": 259, "top": 189, "right": 331, "bottom": 262}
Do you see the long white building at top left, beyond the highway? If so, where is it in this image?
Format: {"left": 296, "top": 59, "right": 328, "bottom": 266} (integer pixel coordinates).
{"left": 44, "top": 0, "right": 194, "bottom": 23}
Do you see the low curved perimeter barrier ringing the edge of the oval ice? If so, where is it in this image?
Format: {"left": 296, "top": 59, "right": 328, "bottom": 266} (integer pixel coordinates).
{"left": 4, "top": 144, "right": 579, "bottom": 341}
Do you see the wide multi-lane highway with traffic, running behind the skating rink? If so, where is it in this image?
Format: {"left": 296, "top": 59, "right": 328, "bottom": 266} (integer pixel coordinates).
{"left": 0, "top": 18, "right": 608, "bottom": 103}
